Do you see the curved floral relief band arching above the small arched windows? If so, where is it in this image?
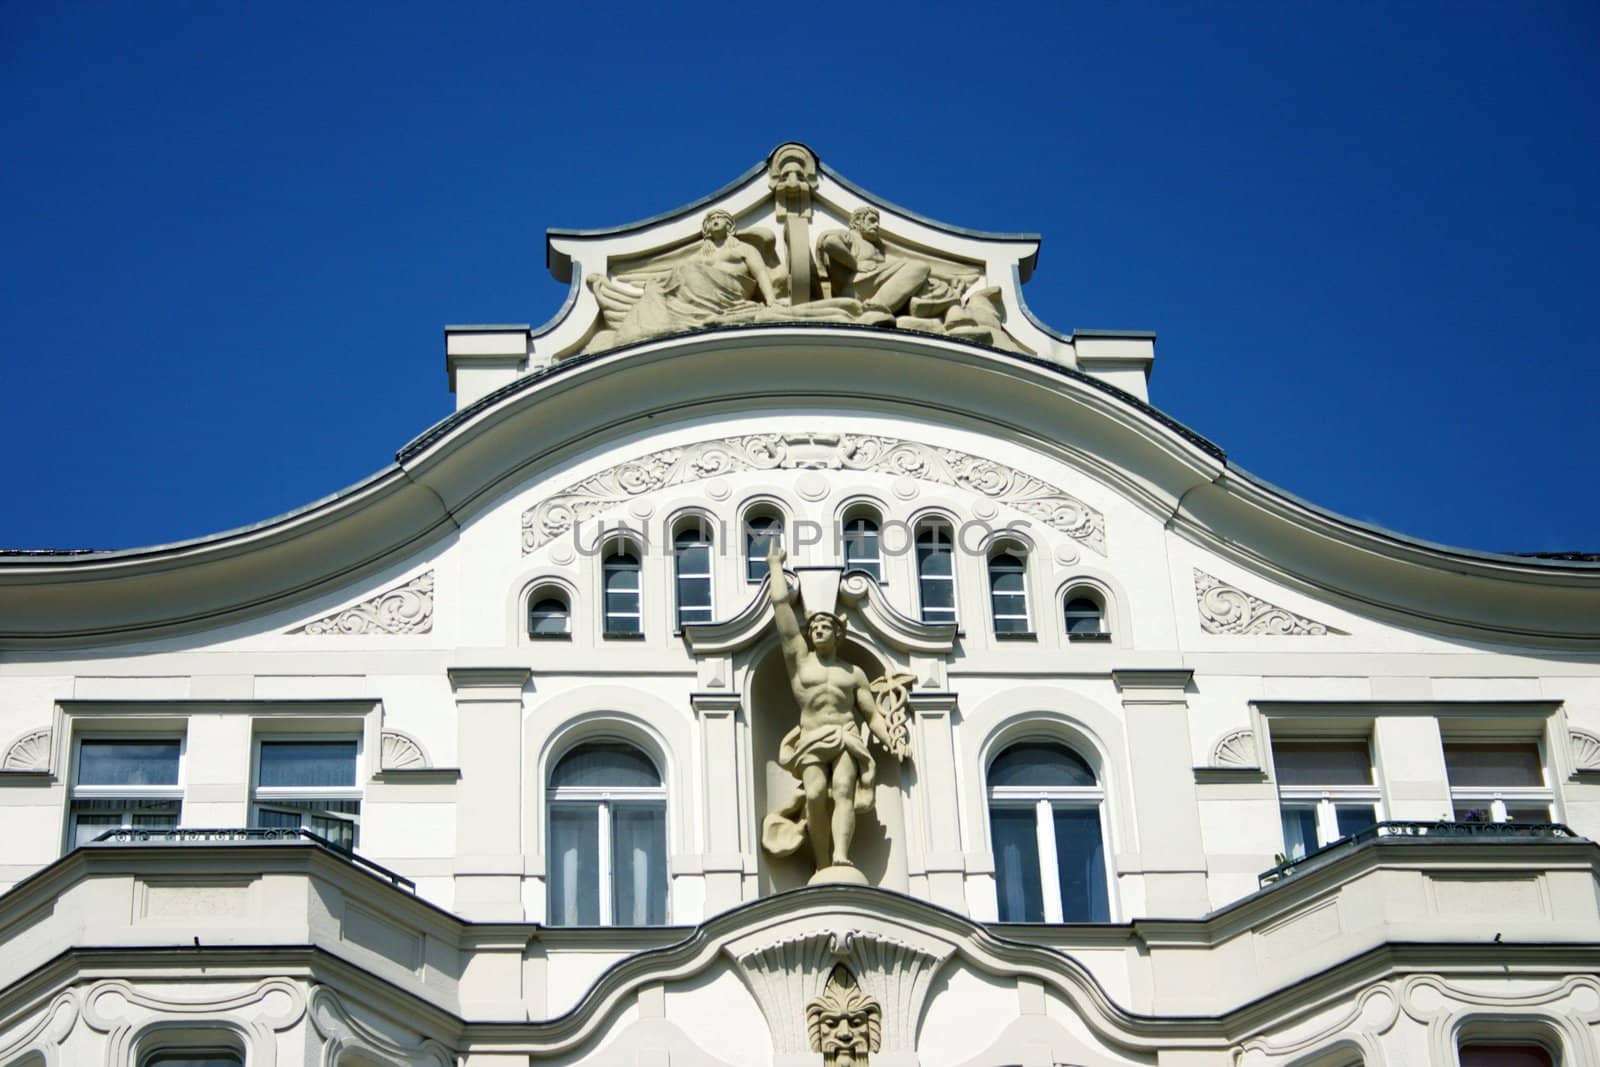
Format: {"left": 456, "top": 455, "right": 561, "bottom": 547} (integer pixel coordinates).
{"left": 522, "top": 434, "right": 1106, "bottom": 555}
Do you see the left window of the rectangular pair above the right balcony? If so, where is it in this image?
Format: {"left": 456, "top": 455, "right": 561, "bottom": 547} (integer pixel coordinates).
{"left": 1272, "top": 737, "right": 1381, "bottom": 859}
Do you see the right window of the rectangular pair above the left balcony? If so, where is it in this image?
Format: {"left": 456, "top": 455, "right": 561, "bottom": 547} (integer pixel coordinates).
{"left": 253, "top": 739, "right": 362, "bottom": 849}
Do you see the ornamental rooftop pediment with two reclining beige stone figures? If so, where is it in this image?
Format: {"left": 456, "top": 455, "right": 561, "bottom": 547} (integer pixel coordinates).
{"left": 536, "top": 144, "right": 1070, "bottom": 360}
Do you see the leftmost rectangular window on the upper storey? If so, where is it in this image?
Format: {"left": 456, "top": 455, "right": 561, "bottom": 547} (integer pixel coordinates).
{"left": 67, "top": 737, "right": 184, "bottom": 848}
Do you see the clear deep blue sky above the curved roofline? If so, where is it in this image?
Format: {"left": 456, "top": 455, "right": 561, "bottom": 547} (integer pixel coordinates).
{"left": 0, "top": 8, "right": 1600, "bottom": 552}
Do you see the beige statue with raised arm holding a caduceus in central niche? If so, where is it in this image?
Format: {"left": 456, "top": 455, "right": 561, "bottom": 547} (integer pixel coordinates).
{"left": 762, "top": 545, "right": 910, "bottom": 881}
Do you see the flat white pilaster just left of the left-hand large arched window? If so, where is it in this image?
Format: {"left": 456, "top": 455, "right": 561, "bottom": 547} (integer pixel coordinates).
{"left": 448, "top": 667, "right": 533, "bottom": 921}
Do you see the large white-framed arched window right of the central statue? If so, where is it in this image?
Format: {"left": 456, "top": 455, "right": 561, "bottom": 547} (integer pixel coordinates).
{"left": 989, "top": 741, "right": 1110, "bottom": 923}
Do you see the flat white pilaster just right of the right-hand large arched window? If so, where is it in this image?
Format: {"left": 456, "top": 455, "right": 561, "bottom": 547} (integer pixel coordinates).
{"left": 1112, "top": 667, "right": 1211, "bottom": 917}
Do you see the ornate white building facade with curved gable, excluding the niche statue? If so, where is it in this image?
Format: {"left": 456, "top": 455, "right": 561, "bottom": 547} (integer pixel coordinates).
{"left": 0, "top": 144, "right": 1600, "bottom": 1067}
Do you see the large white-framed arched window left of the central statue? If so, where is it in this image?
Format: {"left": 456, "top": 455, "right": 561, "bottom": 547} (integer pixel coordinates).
{"left": 549, "top": 741, "right": 667, "bottom": 926}
